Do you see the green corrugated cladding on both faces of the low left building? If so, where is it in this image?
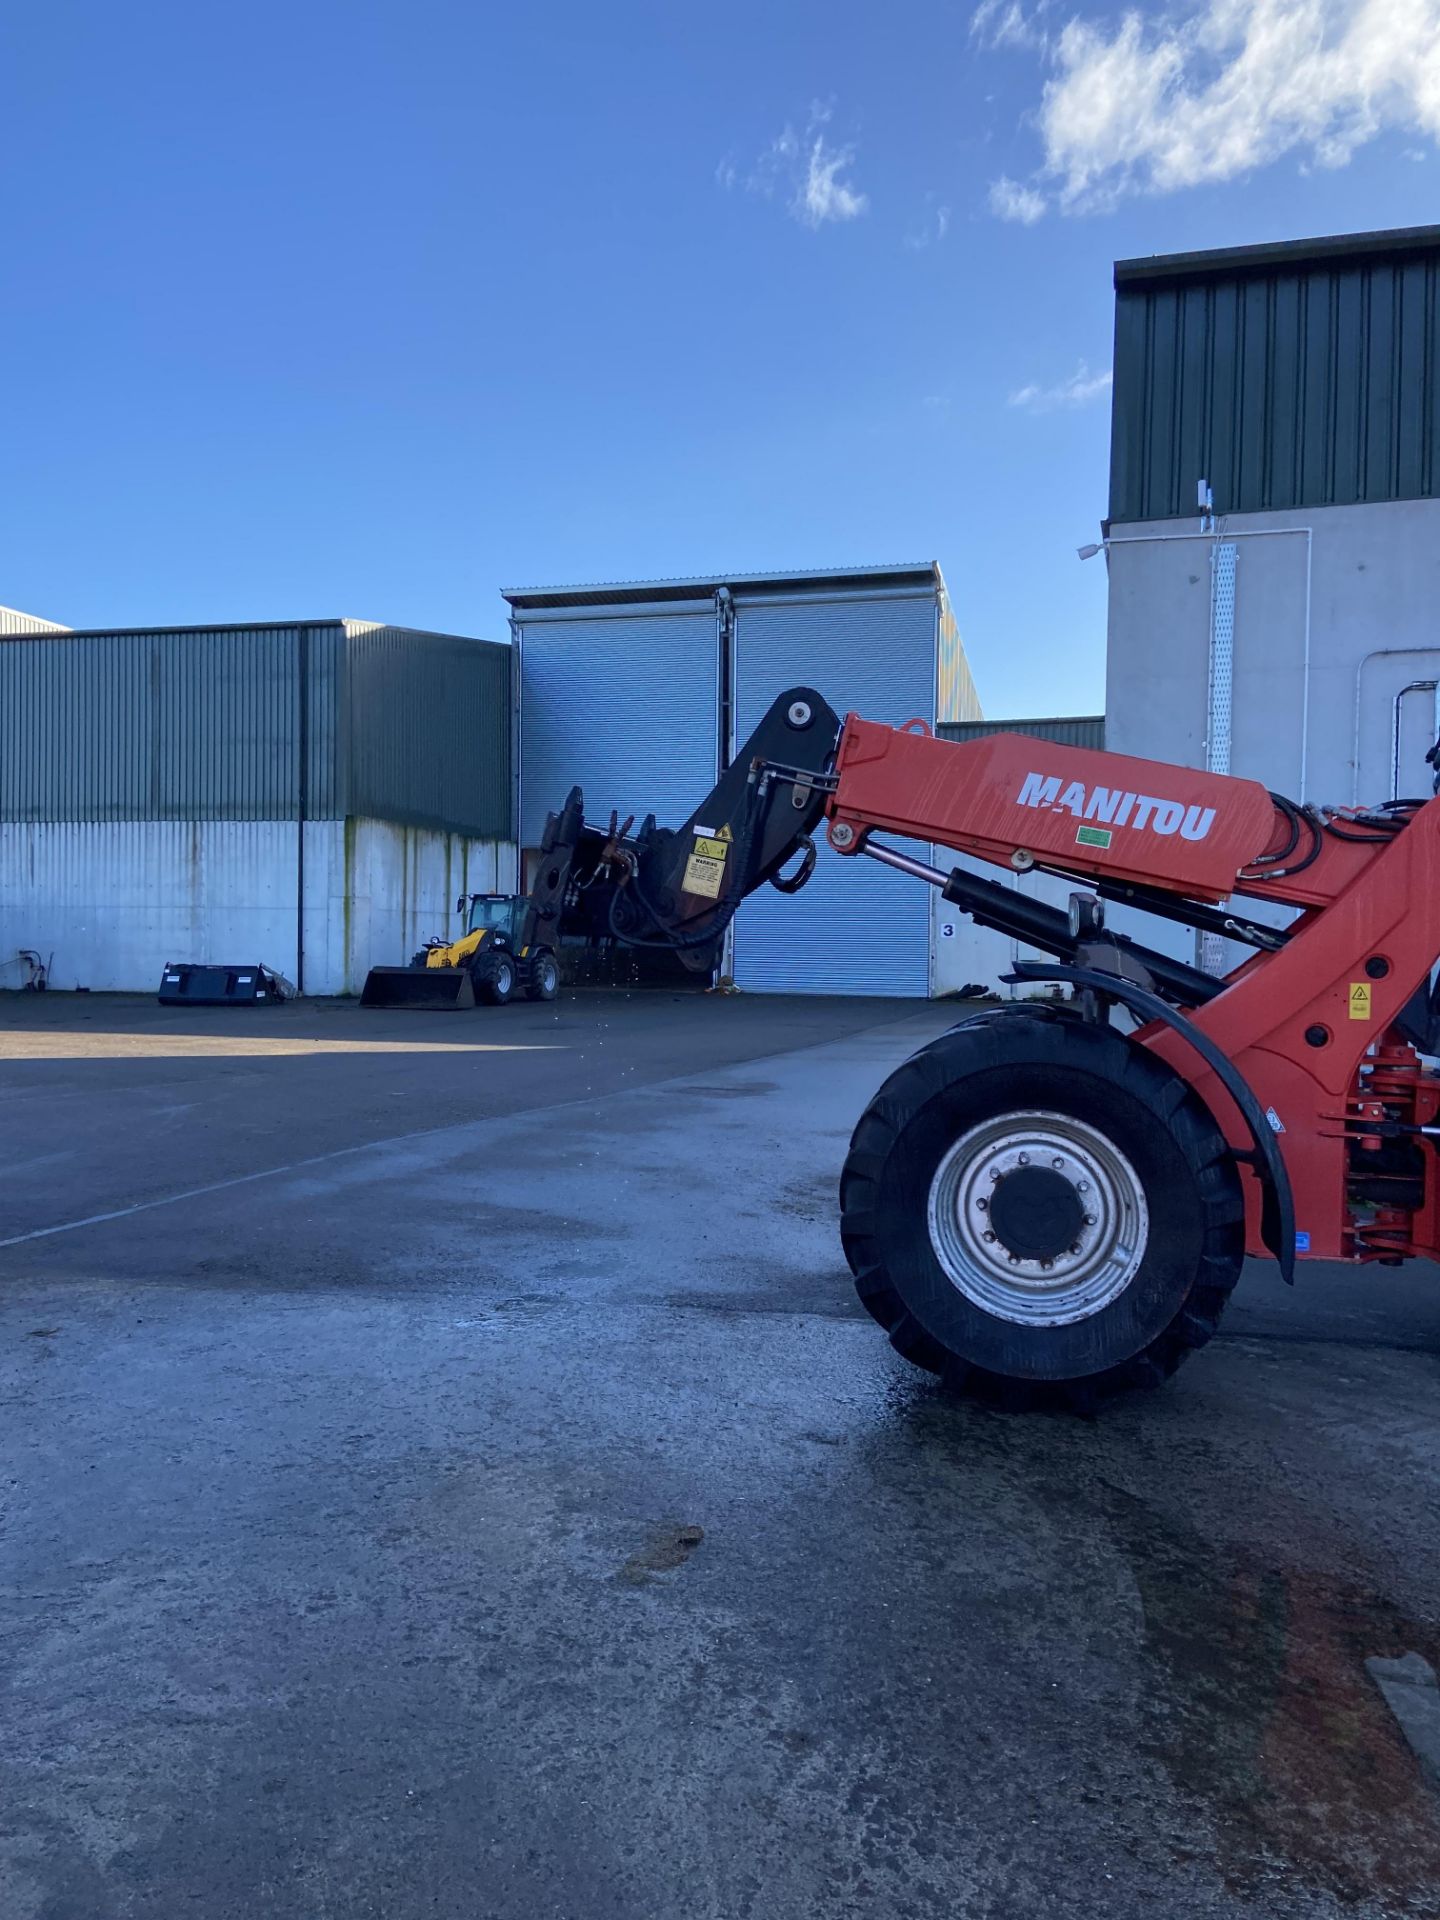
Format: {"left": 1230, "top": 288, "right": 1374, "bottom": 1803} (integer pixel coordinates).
{"left": 0, "top": 620, "right": 513, "bottom": 839}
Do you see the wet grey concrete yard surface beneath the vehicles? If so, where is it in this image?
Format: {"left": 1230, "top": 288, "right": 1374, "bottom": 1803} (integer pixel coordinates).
{"left": 0, "top": 995, "right": 1440, "bottom": 1920}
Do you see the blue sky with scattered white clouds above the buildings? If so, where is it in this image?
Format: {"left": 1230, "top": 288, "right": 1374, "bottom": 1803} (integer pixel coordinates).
{"left": 0, "top": 0, "right": 1440, "bottom": 718}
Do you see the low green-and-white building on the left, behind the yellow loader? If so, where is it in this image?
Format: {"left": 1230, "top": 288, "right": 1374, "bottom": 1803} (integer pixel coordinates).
{"left": 0, "top": 620, "right": 515, "bottom": 993}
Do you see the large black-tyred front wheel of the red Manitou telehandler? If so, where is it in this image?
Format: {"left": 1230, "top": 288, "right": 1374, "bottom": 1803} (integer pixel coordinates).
{"left": 841, "top": 1010, "right": 1244, "bottom": 1407}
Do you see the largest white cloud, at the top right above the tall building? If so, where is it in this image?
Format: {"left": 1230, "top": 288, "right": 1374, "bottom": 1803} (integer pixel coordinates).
{"left": 977, "top": 0, "right": 1440, "bottom": 217}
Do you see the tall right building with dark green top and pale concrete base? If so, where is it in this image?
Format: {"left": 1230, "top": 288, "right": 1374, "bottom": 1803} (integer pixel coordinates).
{"left": 1104, "top": 227, "right": 1440, "bottom": 817}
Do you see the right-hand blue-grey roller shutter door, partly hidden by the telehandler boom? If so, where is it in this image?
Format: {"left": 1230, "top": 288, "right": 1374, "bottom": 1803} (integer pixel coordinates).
{"left": 733, "top": 593, "right": 935, "bottom": 996}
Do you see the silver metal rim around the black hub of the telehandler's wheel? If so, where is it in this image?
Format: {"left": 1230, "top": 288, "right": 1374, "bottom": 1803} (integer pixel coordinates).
{"left": 927, "top": 1110, "right": 1150, "bottom": 1327}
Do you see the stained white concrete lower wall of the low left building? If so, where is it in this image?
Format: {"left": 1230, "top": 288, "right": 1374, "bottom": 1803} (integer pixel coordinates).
{"left": 0, "top": 820, "right": 515, "bottom": 995}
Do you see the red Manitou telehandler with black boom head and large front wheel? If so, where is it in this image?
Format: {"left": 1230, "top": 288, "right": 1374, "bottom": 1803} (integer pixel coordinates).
{"left": 538, "top": 687, "right": 1440, "bottom": 1407}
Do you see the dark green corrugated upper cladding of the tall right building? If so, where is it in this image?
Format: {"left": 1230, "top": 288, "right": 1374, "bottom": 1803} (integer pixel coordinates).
{"left": 1110, "top": 248, "right": 1440, "bottom": 522}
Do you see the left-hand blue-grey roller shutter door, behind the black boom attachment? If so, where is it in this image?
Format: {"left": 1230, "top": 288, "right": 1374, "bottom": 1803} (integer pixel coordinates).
{"left": 520, "top": 607, "right": 720, "bottom": 847}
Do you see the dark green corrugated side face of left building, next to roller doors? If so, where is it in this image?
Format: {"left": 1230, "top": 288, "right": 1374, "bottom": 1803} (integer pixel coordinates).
{"left": 346, "top": 622, "right": 513, "bottom": 839}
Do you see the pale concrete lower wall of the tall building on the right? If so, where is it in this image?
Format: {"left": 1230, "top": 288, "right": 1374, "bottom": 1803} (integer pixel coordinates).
{"left": 1106, "top": 501, "right": 1440, "bottom": 804}
